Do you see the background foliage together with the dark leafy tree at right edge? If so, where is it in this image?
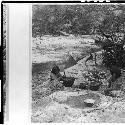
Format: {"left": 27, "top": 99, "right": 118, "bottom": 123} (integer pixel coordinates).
{"left": 32, "top": 4, "right": 125, "bottom": 66}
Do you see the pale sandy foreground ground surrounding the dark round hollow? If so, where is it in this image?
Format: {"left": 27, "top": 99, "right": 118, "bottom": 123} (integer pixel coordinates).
{"left": 32, "top": 91, "right": 125, "bottom": 123}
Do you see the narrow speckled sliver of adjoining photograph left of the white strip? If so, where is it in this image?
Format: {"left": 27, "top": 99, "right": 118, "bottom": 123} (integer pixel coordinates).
{"left": 2, "top": 4, "right": 8, "bottom": 121}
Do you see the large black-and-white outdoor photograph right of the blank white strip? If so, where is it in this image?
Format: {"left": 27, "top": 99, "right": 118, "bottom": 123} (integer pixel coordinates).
{"left": 31, "top": 3, "right": 125, "bottom": 123}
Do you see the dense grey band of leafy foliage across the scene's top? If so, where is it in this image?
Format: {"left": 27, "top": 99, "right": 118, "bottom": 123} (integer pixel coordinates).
{"left": 32, "top": 4, "right": 125, "bottom": 35}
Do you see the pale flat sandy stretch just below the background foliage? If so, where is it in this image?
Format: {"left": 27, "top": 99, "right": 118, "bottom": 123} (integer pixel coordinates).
{"left": 32, "top": 36, "right": 98, "bottom": 63}
